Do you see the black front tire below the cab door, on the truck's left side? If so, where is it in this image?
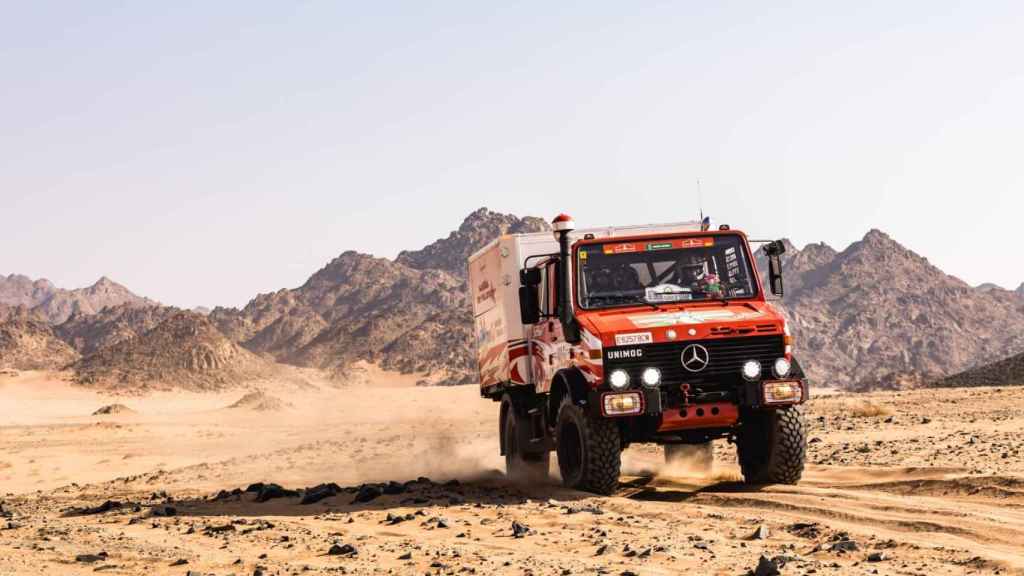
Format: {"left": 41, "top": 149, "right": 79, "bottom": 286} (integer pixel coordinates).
{"left": 555, "top": 396, "right": 623, "bottom": 495}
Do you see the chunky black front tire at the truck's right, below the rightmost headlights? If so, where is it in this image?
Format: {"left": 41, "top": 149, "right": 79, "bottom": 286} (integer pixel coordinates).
{"left": 736, "top": 406, "right": 807, "bottom": 484}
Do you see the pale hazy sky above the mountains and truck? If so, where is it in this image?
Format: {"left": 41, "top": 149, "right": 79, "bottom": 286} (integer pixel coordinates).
{"left": 0, "top": 1, "right": 1024, "bottom": 306}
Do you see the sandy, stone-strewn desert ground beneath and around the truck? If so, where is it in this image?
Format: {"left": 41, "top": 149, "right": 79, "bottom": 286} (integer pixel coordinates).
{"left": 0, "top": 372, "right": 1024, "bottom": 575}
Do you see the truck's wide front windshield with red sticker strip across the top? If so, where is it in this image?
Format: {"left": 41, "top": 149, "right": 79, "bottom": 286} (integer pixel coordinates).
{"left": 577, "top": 235, "right": 757, "bottom": 310}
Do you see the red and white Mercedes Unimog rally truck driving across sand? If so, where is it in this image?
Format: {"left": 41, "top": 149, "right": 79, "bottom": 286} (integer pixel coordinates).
{"left": 469, "top": 214, "right": 809, "bottom": 494}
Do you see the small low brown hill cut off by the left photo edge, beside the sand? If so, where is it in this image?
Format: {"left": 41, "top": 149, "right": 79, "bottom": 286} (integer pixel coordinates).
{"left": 0, "top": 319, "right": 78, "bottom": 370}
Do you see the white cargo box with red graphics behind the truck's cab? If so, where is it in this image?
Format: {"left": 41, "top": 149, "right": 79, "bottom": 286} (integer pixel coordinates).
{"left": 469, "top": 217, "right": 700, "bottom": 387}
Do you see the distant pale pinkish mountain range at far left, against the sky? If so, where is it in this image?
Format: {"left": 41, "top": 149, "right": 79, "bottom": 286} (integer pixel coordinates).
{"left": 0, "top": 275, "right": 156, "bottom": 324}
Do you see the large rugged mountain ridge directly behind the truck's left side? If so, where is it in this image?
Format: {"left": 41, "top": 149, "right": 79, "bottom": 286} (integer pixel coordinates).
{"left": 210, "top": 208, "right": 547, "bottom": 383}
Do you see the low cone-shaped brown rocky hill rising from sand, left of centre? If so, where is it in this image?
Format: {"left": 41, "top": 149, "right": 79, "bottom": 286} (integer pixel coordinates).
{"left": 73, "top": 311, "right": 272, "bottom": 390}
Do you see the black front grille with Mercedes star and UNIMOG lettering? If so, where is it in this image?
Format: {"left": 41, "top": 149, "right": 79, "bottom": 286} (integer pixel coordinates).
{"left": 604, "top": 335, "right": 785, "bottom": 387}
